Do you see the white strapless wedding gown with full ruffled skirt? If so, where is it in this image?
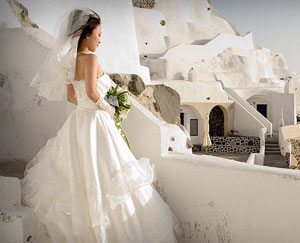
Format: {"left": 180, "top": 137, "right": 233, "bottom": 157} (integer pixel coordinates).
{"left": 21, "top": 74, "right": 181, "bottom": 243}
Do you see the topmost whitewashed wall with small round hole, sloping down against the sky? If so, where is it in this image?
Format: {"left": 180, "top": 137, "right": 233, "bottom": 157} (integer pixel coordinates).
{"left": 134, "top": 0, "right": 238, "bottom": 55}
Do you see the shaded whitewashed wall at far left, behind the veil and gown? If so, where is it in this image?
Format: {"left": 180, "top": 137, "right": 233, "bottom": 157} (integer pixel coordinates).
{"left": 0, "top": 28, "right": 66, "bottom": 159}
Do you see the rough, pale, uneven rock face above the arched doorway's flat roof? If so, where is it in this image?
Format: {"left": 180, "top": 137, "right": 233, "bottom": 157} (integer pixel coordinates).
{"left": 199, "top": 48, "right": 296, "bottom": 87}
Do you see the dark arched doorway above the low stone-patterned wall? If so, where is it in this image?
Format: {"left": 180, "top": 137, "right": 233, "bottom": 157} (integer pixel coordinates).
{"left": 209, "top": 106, "right": 224, "bottom": 136}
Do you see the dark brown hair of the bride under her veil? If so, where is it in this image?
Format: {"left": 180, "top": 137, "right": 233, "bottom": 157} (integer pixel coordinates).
{"left": 69, "top": 9, "right": 101, "bottom": 50}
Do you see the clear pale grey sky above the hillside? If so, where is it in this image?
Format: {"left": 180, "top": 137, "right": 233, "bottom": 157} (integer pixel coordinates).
{"left": 211, "top": 0, "right": 300, "bottom": 74}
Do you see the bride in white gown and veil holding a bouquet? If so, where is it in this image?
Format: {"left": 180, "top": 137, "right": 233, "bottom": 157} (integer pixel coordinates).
{"left": 21, "top": 8, "right": 182, "bottom": 243}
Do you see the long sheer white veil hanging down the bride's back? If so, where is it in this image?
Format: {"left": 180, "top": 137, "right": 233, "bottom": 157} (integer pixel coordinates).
{"left": 30, "top": 7, "right": 95, "bottom": 100}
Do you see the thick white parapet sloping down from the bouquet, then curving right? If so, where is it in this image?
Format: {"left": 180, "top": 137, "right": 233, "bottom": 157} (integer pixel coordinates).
{"left": 123, "top": 93, "right": 300, "bottom": 243}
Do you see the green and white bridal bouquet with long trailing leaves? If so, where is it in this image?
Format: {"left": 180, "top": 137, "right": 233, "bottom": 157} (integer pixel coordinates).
{"left": 104, "top": 85, "right": 131, "bottom": 150}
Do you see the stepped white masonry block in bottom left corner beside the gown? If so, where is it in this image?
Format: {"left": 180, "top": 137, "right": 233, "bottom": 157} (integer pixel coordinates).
{"left": 0, "top": 176, "right": 49, "bottom": 243}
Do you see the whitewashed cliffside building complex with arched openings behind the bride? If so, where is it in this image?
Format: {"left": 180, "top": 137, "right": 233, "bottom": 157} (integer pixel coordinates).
{"left": 134, "top": 0, "right": 300, "bottom": 144}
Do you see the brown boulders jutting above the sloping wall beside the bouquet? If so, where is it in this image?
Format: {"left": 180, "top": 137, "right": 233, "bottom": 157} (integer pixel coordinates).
{"left": 109, "top": 73, "right": 180, "bottom": 124}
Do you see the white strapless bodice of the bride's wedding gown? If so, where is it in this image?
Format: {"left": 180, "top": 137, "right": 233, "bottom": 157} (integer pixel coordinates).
{"left": 71, "top": 73, "right": 116, "bottom": 109}
